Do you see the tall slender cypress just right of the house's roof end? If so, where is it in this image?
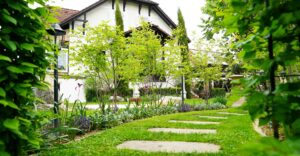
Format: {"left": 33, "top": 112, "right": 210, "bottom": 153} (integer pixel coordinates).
{"left": 177, "top": 9, "right": 192, "bottom": 98}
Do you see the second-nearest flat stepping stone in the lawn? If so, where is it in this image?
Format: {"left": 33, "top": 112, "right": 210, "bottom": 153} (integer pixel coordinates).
{"left": 148, "top": 128, "right": 217, "bottom": 134}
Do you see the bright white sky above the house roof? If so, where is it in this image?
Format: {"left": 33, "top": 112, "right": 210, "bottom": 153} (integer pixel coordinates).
{"left": 50, "top": 0, "right": 207, "bottom": 38}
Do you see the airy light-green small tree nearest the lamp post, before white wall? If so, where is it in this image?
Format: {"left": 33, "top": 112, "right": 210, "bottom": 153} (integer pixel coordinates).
{"left": 70, "top": 22, "right": 125, "bottom": 107}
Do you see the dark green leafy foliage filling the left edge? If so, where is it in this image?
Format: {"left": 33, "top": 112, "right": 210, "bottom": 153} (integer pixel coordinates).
{"left": 0, "top": 0, "right": 54, "bottom": 155}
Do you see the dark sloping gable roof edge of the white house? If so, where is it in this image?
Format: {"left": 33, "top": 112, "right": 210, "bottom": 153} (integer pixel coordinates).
{"left": 60, "top": 0, "right": 177, "bottom": 28}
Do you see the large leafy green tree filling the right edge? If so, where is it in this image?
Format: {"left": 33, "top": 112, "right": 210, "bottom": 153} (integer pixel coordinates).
{"left": 205, "top": 0, "right": 300, "bottom": 142}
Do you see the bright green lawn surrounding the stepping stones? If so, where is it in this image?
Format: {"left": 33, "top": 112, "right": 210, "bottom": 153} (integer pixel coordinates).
{"left": 39, "top": 109, "right": 259, "bottom": 156}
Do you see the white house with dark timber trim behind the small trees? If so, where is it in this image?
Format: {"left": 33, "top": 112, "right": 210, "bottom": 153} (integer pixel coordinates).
{"left": 48, "top": 0, "right": 176, "bottom": 102}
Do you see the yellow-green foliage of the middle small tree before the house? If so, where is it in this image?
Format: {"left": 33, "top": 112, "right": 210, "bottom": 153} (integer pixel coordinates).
{"left": 122, "top": 22, "right": 164, "bottom": 83}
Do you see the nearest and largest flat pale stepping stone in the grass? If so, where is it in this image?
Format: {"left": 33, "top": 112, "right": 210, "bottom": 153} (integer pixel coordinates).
{"left": 117, "top": 141, "right": 220, "bottom": 153}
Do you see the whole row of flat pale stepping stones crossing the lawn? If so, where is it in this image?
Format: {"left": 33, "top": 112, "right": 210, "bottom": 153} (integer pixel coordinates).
{"left": 117, "top": 112, "right": 240, "bottom": 153}
